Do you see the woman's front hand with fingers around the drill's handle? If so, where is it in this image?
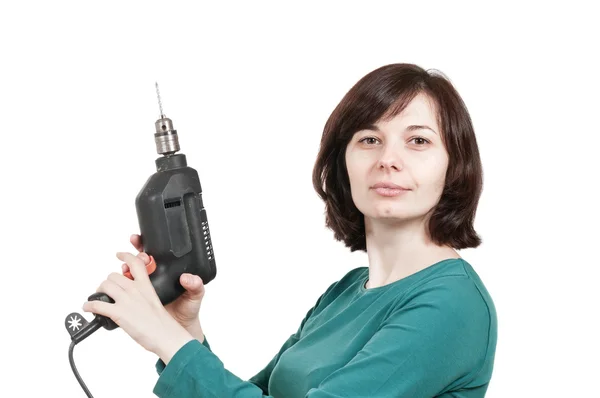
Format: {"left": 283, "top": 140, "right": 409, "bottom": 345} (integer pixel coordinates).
{"left": 83, "top": 253, "right": 194, "bottom": 364}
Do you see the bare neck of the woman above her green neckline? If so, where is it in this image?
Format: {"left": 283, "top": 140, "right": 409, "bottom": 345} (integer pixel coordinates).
{"left": 365, "top": 217, "right": 460, "bottom": 289}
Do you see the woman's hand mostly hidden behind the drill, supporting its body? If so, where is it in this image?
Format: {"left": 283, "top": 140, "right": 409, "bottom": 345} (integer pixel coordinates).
{"left": 123, "top": 234, "right": 205, "bottom": 342}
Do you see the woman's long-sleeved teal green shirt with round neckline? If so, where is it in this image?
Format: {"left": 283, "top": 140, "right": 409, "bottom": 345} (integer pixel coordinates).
{"left": 153, "top": 259, "right": 497, "bottom": 398}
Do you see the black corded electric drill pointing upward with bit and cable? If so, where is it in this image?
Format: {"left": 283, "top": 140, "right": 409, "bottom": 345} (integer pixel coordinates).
{"left": 65, "top": 84, "right": 217, "bottom": 397}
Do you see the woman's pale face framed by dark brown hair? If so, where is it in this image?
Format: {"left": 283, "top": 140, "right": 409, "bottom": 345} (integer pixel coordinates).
{"left": 346, "top": 94, "right": 448, "bottom": 221}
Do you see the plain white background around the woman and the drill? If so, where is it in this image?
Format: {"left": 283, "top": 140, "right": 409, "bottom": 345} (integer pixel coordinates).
{"left": 0, "top": 1, "right": 600, "bottom": 398}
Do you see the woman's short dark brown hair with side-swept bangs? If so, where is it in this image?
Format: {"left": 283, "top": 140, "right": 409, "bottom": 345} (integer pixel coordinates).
{"left": 312, "top": 63, "right": 483, "bottom": 252}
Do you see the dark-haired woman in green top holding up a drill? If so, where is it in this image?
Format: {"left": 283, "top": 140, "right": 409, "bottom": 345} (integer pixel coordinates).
{"left": 84, "top": 64, "right": 497, "bottom": 398}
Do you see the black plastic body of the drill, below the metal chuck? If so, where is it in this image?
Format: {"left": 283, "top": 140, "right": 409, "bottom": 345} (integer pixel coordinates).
{"left": 135, "top": 154, "right": 217, "bottom": 305}
